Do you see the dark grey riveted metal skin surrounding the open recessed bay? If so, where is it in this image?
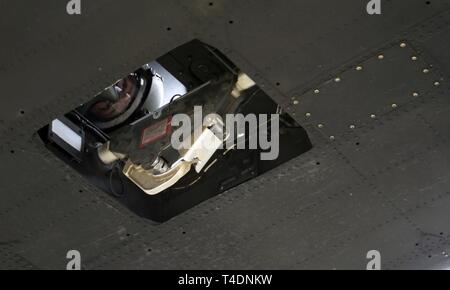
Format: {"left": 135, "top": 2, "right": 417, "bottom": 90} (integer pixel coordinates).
{"left": 0, "top": 0, "right": 450, "bottom": 269}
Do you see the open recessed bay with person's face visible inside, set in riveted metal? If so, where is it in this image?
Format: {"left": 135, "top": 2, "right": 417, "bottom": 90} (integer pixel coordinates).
{"left": 38, "top": 40, "right": 312, "bottom": 222}
